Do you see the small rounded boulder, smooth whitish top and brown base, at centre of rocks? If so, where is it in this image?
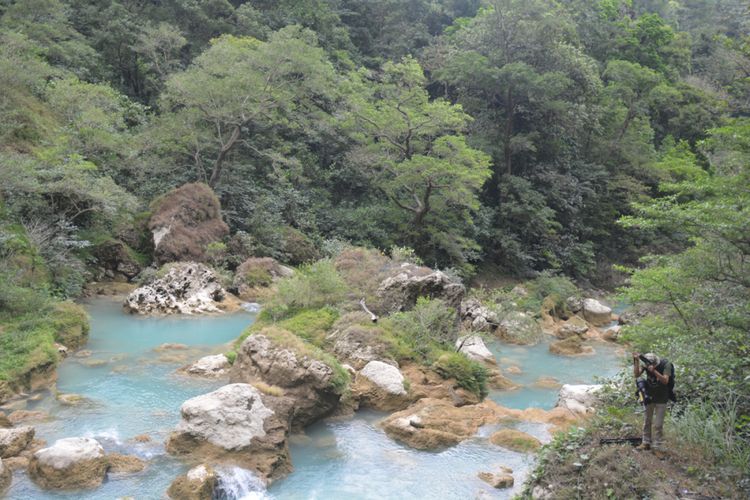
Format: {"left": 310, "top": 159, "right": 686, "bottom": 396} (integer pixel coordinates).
{"left": 354, "top": 361, "right": 410, "bottom": 411}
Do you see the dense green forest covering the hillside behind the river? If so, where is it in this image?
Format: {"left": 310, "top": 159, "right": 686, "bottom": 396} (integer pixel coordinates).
{"left": 0, "top": 0, "right": 750, "bottom": 496}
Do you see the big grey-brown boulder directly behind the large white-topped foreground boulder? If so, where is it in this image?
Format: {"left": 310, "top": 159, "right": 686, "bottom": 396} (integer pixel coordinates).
{"left": 230, "top": 328, "right": 342, "bottom": 428}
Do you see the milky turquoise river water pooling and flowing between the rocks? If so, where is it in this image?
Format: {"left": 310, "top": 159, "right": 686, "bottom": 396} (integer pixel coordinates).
{"left": 6, "top": 299, "right": 621, "bottom": 500}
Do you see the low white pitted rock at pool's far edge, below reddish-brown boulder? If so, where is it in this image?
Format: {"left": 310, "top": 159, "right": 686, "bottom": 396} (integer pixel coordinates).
{"left": 125, "top": 262, "right": 226, "bottom": 314}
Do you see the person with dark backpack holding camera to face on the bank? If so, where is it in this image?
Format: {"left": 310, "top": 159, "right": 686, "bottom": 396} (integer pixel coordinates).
{"left": 633, "top": 352, "right": 676, "bottom": 458}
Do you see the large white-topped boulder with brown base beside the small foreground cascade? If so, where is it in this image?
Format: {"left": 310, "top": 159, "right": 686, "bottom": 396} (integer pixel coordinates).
{"left": 167, "top": 384, "right": 291, "bottom": 478}
